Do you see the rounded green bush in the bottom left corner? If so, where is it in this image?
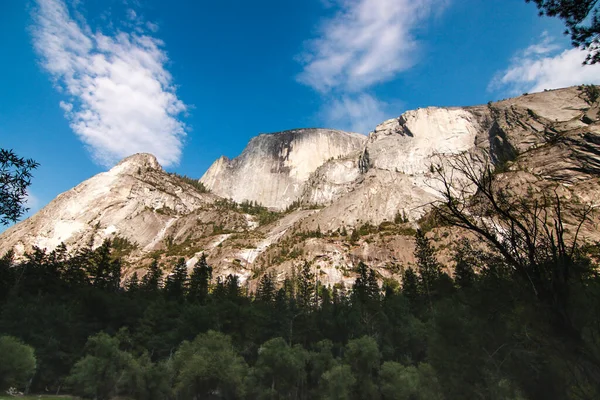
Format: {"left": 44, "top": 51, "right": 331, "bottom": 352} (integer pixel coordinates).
{"left": 0, "top": 336, "right": 36, "bottom": 391}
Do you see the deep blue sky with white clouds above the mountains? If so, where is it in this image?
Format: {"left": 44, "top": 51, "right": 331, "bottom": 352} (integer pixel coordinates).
{"left": 0, "top": 0, "right": 600, "bottom": 228}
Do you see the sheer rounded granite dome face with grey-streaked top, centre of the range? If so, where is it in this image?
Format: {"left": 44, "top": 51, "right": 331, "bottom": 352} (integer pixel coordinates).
{"left": 200, "top": 129, "right": 367, "bottom": 209}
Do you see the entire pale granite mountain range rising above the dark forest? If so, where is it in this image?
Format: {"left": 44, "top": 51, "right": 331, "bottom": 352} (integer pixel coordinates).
{"left": 0, "top": 87, "right": 600, "bottom": 284}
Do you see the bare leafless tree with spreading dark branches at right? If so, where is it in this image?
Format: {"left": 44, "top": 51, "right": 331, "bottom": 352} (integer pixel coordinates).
{"left": 432, "top": 151, "right": 600, "bottom": 383}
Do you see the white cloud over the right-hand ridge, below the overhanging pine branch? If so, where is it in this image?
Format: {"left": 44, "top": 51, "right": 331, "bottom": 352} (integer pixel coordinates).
{"left": 488, "top": 32, "right": 600, "bottom": 95}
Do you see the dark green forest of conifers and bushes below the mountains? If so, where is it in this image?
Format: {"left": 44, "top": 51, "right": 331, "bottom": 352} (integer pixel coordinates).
{"left": 0, "top": 228, "right": 600, "bottom": 399}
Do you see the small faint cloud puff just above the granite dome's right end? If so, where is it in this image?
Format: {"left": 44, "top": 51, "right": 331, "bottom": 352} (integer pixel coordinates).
{"left": 323, "top": 94, "right": 388, "bottom": 134}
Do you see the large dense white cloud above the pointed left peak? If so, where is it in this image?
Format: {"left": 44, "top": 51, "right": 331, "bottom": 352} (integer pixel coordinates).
{"left": 32, "top": 0, "right": 186, "bottom": 166}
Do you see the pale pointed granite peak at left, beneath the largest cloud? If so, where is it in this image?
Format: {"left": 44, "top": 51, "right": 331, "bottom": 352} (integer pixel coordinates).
{"left": 0, "top": 154, "right": 212, "bottom": 253}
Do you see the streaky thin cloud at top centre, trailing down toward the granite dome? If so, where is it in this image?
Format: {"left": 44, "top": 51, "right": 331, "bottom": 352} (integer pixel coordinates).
{"left": 297, "top": 0, "right": 447, "bottom": 133}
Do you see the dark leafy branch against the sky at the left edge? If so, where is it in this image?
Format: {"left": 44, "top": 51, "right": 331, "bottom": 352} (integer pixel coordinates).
{"left": 0, "top": 148, "right": 39, "bottom": 225}
